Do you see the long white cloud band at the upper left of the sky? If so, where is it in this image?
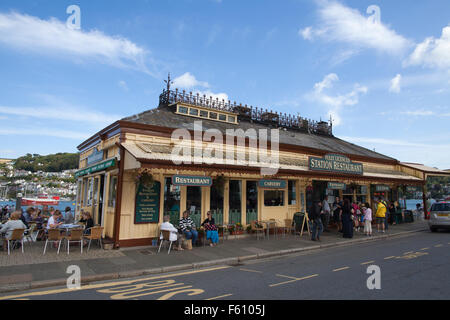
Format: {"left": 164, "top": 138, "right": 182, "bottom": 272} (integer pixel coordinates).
{"left": 0, "top": 13, "right": 152, "bottom": 74}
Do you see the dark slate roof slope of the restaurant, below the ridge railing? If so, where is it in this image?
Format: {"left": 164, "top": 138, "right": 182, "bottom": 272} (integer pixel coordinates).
{"left": 122, "top": 105, "right": 397, "bottom": 161}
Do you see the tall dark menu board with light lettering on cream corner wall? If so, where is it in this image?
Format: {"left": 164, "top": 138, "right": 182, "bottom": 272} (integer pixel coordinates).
{"left": 134, "top": 181, "right": 161, "bottom": 224}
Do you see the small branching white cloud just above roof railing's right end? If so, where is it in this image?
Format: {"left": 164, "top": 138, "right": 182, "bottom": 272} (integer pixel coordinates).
{"left": 310, "top": 73, "right": 368, "bottom": 126}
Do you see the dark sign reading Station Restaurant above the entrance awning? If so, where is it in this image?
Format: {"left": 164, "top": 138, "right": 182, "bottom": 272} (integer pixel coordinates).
{"left": 308, "top": 154, "right": 363, "bottom": 175}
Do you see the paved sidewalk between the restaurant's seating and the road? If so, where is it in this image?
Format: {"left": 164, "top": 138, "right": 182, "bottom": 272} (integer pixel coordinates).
{"left": 0, "top": 221, "right": 428, "bottom": 292}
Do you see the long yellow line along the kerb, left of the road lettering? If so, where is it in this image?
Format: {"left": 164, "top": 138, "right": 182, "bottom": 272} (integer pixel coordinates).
{"left": 0, "top": 266, "right": 231, "bottom": 300}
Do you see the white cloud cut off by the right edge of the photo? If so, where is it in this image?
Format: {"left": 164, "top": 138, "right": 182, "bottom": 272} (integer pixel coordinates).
{"left": 403, "top": 26, "right": 450, "bottom": 69}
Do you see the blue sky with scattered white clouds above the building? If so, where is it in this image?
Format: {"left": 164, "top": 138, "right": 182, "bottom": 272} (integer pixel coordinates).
{"left": 0, "top": 0, "right": 450, "bottom": 169}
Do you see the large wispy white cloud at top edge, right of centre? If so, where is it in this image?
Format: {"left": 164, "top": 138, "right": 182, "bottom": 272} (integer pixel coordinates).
{"left": 299, "top": 1, "right": 412, "bottom": 55}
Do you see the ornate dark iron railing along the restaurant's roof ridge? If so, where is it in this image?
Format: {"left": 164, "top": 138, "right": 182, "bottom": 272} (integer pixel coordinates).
{"left": 159, "top": 89, "right": 333, "bottom": 136}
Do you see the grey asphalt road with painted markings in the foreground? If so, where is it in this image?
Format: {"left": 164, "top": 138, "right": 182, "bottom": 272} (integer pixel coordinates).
{"left": 0, "top": 232, "right": 450, "bottom": 300}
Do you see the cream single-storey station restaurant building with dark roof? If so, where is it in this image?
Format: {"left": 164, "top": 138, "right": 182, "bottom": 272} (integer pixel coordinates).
{"left": 76, "top": 78, "right": 446, "bottom": 248}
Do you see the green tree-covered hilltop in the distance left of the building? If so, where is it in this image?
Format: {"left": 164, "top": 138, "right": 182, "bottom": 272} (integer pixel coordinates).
{"left": 14, "top": 153, "right": 79, "bottom": 172}
